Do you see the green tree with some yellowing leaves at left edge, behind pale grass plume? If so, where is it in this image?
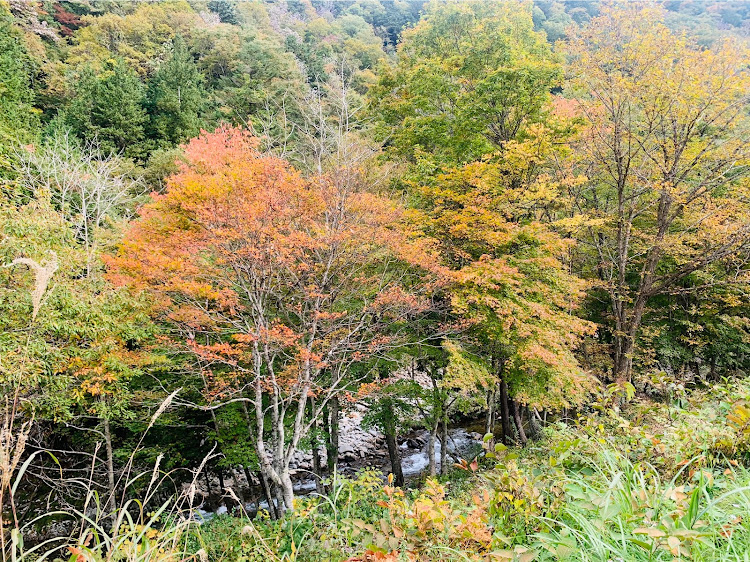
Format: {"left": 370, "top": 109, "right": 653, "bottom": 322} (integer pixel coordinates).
{"left": 0, "top": 186, "right": 152, "bottom": 520}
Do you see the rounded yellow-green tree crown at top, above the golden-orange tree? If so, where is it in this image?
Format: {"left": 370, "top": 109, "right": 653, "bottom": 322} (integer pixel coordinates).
{"left": 371, "top": 0, "right": 561, "bottom": 163}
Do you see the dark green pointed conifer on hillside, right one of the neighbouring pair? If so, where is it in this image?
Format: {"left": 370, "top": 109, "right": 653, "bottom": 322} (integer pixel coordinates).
{"left": 147, "top": 36, "right": 205, "bottom": 144}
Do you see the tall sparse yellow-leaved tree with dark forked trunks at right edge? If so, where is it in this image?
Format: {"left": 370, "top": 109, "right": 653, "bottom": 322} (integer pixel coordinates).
{"left": 566, "top": 6, "right": 750, "bottom": 382}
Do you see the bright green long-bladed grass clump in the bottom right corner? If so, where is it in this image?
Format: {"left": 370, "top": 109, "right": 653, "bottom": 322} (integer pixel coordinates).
{"left": 537, "top": 450, "right": 750, "bottom": 562}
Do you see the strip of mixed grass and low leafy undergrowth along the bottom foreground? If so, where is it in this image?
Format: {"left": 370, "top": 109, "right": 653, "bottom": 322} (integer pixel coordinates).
{"left": 5, "top": 378, "right": 750, "bottom": 562}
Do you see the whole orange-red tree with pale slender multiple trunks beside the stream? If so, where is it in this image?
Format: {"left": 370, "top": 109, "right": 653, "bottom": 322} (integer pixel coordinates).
{"left": 110, "top": 124, "right": 432, "bottom": 509}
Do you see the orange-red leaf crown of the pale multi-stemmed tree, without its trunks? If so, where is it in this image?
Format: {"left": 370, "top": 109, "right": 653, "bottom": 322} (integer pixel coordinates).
{"left": 111, "top": 123, "right": 428, "bottom": 365}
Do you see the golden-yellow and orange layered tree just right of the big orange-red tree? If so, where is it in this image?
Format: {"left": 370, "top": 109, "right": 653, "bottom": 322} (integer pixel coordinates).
{"left": 412, "top": 125, "right": 593, "bottom": 435}
